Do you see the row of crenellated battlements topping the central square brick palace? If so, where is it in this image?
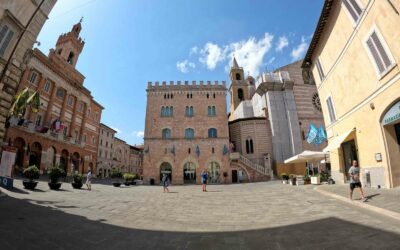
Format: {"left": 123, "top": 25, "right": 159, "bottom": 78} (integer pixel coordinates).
{"left": 147, "top": 81, "right": 226, "bottom": 90}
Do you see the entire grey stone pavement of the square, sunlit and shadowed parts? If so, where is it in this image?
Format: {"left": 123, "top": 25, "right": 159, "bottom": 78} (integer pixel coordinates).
{"left": 0, "top": 180, "right": 400, "bottom": 249}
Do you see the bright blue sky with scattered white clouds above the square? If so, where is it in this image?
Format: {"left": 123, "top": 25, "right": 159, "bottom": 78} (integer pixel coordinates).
{"left": 38, "top": 0, "right": 323, "bottom": 144}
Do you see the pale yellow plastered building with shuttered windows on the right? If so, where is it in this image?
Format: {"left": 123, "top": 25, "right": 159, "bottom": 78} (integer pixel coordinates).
{"left": 303, "top": 0, "right": 400, "bottom": 188}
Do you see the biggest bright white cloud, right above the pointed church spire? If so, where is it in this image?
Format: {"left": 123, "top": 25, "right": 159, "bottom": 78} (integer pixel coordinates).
{"left": 229, "top": 33, "right": 274, "bottom": 76}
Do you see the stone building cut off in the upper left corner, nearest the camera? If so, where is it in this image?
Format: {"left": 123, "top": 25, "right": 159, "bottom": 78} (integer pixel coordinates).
{"left": 0, "top": 0, "right": 56, "bottom": 141}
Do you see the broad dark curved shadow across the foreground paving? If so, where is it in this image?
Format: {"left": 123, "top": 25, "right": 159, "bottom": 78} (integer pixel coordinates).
{"left": 0, "top": 196, "right": 400, "bottom": 249}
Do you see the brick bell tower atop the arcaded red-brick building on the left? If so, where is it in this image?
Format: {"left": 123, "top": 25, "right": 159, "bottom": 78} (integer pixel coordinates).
{"left": 55, "top": 18, "right": 85, "bottom": 68}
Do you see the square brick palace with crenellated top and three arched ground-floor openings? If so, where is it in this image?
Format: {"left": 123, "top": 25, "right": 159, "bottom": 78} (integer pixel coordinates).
{"left": 143, "top": 81, "right": 231, "bottom": 184}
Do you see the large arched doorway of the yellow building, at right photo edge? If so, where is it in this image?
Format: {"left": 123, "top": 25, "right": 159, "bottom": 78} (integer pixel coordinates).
{"left": 381, "top": 101, "right": 400, "bottom": 187}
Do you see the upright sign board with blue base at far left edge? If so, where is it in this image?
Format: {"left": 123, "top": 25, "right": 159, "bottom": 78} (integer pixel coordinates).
{"left": 0, "top": 146, "right": 17, "bottom": 188}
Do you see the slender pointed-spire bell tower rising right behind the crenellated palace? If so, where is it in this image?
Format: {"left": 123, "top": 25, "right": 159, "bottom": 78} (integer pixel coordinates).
{"left": 229, "top": 57, "right": 249, "bottom": 120}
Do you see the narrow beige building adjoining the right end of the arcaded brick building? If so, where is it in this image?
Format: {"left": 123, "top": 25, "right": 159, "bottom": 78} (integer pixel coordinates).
{"left": 97, "top": 123, "right": 117, "bottom": 178}
